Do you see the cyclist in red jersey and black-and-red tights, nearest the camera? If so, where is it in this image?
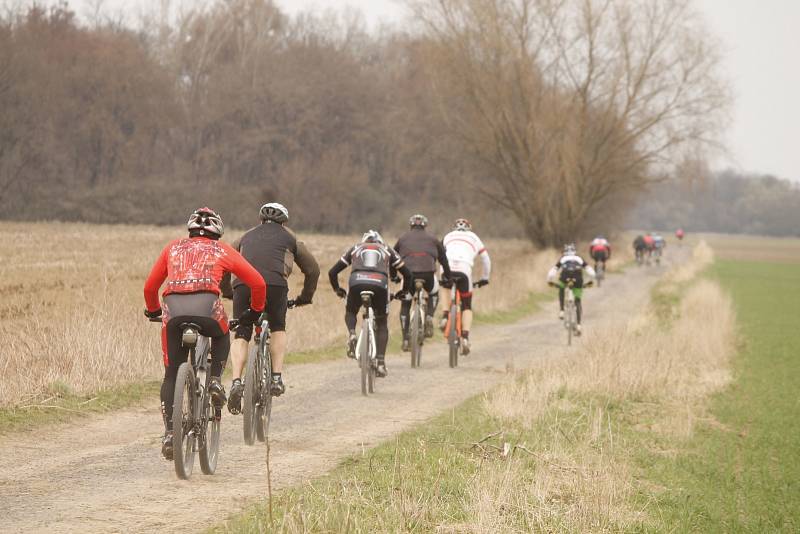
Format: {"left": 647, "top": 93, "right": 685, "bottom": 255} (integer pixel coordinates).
{"left": 144, "top": 208, "right": 266, "bottom": 460}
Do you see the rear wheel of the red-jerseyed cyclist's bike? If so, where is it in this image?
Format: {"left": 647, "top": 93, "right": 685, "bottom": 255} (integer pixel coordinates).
{"left": 172, "top": 362, "right": 197, "bottom": 480}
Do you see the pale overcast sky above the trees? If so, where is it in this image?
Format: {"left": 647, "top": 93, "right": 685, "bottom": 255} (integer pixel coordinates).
{"left": 34, "top": 0, "right": 800, "bottom": 181}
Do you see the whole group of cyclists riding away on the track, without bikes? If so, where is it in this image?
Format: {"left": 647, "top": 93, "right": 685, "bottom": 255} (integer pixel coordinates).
{"left": 144, "top": 202, "right": 663, "bottom": 459}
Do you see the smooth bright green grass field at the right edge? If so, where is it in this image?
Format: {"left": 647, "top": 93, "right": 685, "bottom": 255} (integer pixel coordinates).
{"left": 641, "top": 260, "right": 800, "bottom": 532}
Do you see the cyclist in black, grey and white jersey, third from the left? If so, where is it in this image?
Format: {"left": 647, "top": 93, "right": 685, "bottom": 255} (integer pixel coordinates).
{"left": 328, "top": 230, "right": 412, "bottom": 377}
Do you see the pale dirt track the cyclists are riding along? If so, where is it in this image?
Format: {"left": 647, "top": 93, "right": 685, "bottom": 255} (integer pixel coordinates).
{"left": 0, "top": 258, "right": 676, "bottom": 532}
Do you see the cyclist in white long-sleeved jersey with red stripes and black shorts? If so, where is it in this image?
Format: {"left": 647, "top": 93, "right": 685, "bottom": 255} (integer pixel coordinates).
{"left": 440, "top": 219, "right": 492, "bottom": 356}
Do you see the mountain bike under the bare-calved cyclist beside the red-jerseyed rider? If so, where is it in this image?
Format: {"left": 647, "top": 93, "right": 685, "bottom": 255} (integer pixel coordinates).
{"left": 230, "top": 300, "right": 295, "bottom": 445}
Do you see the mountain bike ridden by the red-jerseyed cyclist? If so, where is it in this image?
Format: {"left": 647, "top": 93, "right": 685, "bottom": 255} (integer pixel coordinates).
{"left": 172, "top": 322, "right": 222, "bottom": 480}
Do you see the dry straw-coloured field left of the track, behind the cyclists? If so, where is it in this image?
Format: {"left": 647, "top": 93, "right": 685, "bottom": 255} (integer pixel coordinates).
{"left": 0, "top": 223, "right": 555, "bottom": 406}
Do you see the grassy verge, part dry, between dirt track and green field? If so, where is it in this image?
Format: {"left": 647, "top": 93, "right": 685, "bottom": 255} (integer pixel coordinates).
{"left": 215, "top": 244, "right": 733, "bottom": 532}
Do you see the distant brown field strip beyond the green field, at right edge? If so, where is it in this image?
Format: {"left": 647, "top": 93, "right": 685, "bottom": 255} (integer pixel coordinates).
{"left": 699, "top": 234, "right": 800, "bottom": 263}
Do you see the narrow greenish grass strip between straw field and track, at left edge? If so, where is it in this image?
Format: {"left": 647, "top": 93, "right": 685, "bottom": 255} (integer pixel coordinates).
{"left": 0, "top": 382, "right": 161, "bottom": 435}
